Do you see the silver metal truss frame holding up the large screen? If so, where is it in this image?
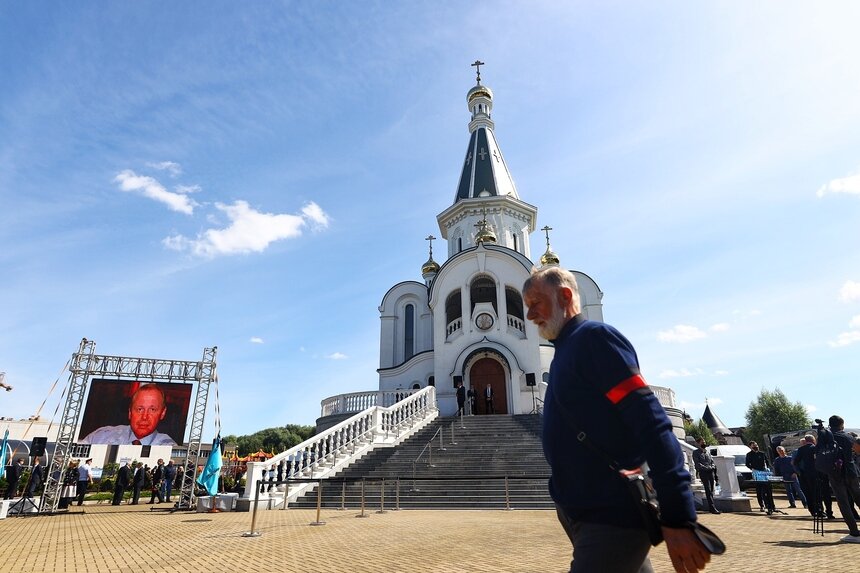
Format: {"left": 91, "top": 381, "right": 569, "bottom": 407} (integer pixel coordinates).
{"left": 39, "top": 338, "right": 218, "bottom": 513}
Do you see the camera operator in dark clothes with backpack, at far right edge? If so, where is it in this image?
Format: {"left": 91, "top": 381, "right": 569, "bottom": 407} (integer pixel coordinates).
{"left": 815, "top": 415, "right": 860, "bottom": 543}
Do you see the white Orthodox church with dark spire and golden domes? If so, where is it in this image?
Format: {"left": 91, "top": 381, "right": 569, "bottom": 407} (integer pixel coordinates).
{"left": 378, "top": 66, "right": 603, "bottom": 416}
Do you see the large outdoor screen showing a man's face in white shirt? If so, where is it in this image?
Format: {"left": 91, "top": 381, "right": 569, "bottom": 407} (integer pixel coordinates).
{"left": 78, "top": 378, "right": 193, "bottom": 446}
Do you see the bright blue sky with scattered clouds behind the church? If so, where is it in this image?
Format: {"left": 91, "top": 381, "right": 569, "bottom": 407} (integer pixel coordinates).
{"left": 0, "top": 1, "right": 860, "bottom": 434}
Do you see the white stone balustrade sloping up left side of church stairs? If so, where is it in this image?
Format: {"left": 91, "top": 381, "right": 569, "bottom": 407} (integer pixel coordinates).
{"left": 242, "top": 386, "right": 439, "bottom": 499}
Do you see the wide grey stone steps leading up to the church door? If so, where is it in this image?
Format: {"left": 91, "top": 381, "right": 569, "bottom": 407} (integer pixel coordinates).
{"left": 289, "top": 415, "right": 554, "bottom": 511}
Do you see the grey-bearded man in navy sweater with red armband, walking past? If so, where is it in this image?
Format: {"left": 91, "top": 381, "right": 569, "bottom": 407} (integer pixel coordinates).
{"left": 523, "top": 267, "right": 710, "bottom": 573}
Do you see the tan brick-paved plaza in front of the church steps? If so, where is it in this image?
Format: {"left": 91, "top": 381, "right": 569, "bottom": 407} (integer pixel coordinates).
{"left": 0, "top": 504, "right": 860, "bottom": 573}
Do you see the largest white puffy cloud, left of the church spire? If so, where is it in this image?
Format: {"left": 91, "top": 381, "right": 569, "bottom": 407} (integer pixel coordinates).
{"left": 162, "top": 201, "right": 328, "bottom": 257}
